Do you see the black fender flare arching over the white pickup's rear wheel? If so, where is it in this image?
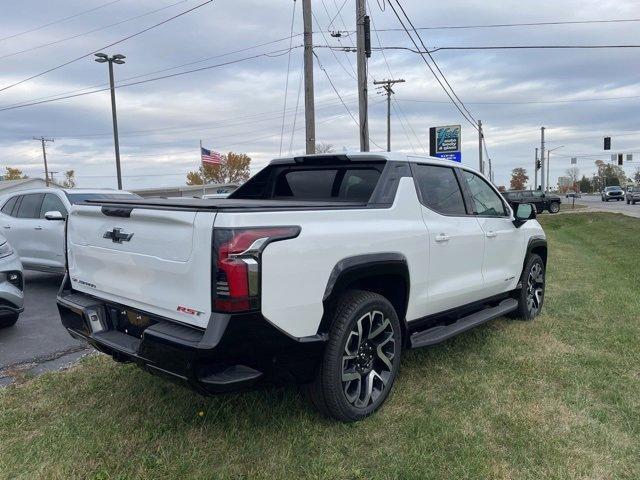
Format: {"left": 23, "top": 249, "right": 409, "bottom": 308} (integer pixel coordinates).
{"left": 318, "top": 252, "right": 411, "bottom": 332}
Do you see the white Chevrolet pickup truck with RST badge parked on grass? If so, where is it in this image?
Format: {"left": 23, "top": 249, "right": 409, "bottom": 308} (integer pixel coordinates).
{"left": 58, "top": 153, "right": 547, "bottom": 421}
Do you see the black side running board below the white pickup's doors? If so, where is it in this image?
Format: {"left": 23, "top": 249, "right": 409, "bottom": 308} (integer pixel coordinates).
{"left": 410, "top": 298, "right": 518, "bottom": 348}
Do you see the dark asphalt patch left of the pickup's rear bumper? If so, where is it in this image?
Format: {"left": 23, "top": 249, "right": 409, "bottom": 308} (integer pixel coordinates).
{"left": 0, "top": 271, "right": 86, "bottom": 370}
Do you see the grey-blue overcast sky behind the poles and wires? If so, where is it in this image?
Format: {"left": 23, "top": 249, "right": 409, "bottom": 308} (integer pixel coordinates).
{"left": 0, "top": 0, "right": 640, "bottom": 189}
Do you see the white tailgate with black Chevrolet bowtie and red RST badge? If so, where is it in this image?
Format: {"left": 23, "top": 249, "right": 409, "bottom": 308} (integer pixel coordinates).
{"left": 67, "top": 205, "right": 215, "bottom": 327}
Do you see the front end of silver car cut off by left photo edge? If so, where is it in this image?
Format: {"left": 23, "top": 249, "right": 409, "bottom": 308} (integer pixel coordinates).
{"left": 0, "top": 235, "right": 24, "bottom": 328}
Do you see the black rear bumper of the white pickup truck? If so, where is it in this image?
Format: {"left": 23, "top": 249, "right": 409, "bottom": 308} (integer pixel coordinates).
{"left": 58, "top": 279, "right": 325, "bottom": 394}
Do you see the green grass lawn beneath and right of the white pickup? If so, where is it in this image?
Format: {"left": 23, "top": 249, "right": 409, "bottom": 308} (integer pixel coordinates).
{"left": 0, "top": 213, "right": 640, "bottom": 479}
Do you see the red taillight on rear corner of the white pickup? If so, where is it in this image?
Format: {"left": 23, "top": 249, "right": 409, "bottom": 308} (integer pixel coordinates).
{"left": 213, "top": 227, "right": 300, "bottom": 312}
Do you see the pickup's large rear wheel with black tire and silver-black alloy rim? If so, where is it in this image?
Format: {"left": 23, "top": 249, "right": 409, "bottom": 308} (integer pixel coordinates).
{"left": 304, "top": 290, "right": 402, "bottom": 422}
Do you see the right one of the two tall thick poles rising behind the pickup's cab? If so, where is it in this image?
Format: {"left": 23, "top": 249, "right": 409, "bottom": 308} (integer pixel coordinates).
{"left": 356, "top": 0, "right": 371, "bottom": 152}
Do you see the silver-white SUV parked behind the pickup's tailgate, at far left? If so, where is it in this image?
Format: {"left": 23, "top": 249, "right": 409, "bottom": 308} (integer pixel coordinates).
{"left": 0, "top": 188, "right": 140, "bottom": 273}
